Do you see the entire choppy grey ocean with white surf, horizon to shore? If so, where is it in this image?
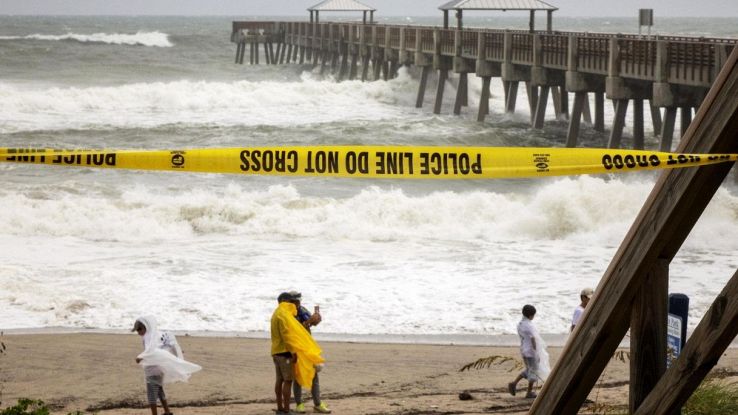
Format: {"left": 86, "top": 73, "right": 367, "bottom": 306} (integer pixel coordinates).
{"left": 0, "top": 16, "right": 738, "bottom": 337}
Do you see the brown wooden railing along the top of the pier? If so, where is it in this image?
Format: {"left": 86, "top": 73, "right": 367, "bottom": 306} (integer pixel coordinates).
{"left": 231, "top": 21, "right": 738, "bottom": 87}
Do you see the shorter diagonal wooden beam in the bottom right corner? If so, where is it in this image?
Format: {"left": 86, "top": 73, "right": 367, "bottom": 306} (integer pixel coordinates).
{"left": 635, "top": 271, "right": 738, "bottom": 415}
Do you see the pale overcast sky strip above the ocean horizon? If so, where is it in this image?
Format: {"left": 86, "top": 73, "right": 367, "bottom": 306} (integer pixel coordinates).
{"left": 0, "top": 0, "right": 738, "bottom": 17}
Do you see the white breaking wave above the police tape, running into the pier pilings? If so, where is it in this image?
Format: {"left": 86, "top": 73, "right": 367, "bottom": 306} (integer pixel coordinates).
{"left": 0, "top": 72, "right": 415, "bottom": 133}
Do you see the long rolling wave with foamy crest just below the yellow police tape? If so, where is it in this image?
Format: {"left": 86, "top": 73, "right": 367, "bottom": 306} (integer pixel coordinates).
{"left": 0, "top": 176, "right": 738, "bottom": 250}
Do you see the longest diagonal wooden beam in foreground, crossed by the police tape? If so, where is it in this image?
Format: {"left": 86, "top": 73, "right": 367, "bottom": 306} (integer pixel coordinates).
{"left": 529, "top": 48, "right": 738, "bottom": 415}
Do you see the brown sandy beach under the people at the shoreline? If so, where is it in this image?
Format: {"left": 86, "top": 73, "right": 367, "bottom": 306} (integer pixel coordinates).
{"left": 0, "top": 333, "right": 738, "bottom": 415}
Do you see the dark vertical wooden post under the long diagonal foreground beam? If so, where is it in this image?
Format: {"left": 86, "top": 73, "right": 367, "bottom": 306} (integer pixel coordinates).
{"left": 630, "top": 260, "right": 669, "bottom": 413}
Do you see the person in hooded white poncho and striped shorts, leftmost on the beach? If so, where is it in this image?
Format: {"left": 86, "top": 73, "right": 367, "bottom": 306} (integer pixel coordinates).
{"left": 132, "top": 316, "right": 202, "bottom": 415}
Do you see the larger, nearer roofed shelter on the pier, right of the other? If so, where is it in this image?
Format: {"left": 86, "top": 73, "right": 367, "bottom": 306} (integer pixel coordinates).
{"left": 439, "top": 0, "right": 558, "bottom": 32}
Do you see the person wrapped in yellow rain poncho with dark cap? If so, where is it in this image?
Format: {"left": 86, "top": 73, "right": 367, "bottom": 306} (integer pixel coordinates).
{"left": 271, "top": 293, "right": 325, "bottom": 413}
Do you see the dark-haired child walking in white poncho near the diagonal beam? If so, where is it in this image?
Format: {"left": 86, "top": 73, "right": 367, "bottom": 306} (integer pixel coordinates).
{"left": 507, "top": 304, "right": 551, "bottom": 398}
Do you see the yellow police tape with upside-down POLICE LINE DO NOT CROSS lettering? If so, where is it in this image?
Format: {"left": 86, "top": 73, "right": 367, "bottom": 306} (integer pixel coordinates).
{"left": 0, "top": 146, "right": 738, "bottom": 179}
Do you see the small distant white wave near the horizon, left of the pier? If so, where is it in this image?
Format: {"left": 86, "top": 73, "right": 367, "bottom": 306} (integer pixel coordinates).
{"left": 0, "top": 31, "right": 174, "bottom": 48}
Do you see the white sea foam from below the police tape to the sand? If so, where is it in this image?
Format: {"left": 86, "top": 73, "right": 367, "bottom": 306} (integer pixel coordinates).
{"left": 0, "top": 176, "right": 738, "bottom": 334}
